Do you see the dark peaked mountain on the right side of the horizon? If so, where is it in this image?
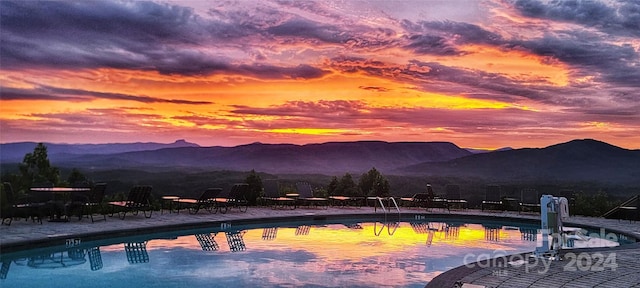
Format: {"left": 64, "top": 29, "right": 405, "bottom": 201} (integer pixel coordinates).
{"left": 396, "top": 139, "right": 640, "bottom": 187}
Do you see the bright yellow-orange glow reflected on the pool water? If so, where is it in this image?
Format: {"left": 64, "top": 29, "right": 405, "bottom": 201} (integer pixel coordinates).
{"left": 138, "top": 223, "right": 521, "bottom": 261}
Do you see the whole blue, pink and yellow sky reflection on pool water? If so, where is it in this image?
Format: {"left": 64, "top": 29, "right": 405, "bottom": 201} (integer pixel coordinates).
{"left": 2, "top": 222, "right": 536, "bottom": 287}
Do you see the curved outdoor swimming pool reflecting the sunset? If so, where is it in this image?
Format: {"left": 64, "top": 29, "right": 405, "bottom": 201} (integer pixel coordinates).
{"left": 0, "top": 215, "right": 632, "bottom": 287}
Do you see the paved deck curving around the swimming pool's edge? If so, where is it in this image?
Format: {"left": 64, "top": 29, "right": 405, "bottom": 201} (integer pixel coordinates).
{"left": 0, "top": 207, "right": 640, "bottom": 288}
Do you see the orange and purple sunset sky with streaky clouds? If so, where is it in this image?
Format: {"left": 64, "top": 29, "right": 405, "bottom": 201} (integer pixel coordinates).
{"left": 0, "top": 0, "right": 640, "bottom": 149}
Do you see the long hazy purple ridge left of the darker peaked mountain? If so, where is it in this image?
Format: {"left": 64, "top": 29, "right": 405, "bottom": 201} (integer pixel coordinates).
{"left": 2, "top": 141, "right": 471, "bottom": 174}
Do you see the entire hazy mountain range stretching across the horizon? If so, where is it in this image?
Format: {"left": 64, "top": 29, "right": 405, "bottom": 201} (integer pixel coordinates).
{"left": 0, "top": 139, "right": 640, "bottom": 187}
